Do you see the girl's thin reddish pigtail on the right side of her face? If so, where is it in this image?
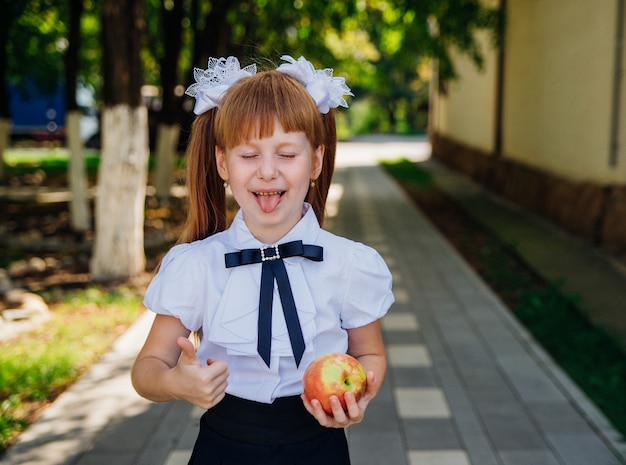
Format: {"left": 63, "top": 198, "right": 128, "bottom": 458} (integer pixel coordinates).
{"left": 306, "top": 109, "right": 337, "bottom": 226}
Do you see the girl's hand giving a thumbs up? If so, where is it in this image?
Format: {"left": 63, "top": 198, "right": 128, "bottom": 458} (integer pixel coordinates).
{"left": 172, "top": 337, "right": 228, "bottom": 409}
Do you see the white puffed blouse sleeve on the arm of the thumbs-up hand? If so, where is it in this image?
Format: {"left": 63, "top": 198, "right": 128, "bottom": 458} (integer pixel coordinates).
{"left": 143, "top": 244, "right": 205, "bottom": 331}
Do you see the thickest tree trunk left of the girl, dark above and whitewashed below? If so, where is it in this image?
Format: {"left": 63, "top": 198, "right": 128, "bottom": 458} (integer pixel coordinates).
{"left": 91, "top": 0, "right": 149, "bottom": 281}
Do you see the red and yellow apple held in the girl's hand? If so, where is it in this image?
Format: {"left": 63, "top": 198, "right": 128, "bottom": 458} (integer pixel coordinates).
{"left": 303, "top": 353, "right": 367, "bottom": 414}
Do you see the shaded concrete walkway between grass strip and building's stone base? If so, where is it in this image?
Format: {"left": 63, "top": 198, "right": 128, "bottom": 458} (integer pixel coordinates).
{"left": 422, "top": 161, "right": 626, "bottom": 347}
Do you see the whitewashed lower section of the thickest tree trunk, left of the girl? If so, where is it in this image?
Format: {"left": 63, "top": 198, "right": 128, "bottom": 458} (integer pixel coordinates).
{"left": 91, "top": 104, "right": 148, "bottom": 281}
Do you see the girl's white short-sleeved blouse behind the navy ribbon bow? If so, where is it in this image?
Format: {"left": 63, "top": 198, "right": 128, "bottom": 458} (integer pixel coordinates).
{"left": 144, "top": 204, "right": 394, "bottom": 403}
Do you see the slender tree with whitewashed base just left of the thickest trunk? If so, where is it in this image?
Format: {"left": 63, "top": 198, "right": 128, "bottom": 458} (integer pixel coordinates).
{"left": 65, "top": 0, "right": 90, "bottom": 232}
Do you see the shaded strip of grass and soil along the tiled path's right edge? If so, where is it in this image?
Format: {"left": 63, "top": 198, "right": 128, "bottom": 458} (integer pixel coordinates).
{"left": 383, "top": 160, "right": 626, "bottom": 436}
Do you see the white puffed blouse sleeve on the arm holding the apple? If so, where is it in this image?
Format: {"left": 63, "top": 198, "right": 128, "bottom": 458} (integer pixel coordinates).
{"left": 341, "top": 243, "right": 394, "bottom": 329}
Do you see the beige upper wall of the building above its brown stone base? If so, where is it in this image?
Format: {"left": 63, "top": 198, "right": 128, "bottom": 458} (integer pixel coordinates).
{"left": 432, "top": 0, "right": 626, "bottom": 183}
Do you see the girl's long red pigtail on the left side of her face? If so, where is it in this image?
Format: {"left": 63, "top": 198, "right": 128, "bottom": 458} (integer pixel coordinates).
{"left": 179, "top": 108, "right": 226, "bottom": 243}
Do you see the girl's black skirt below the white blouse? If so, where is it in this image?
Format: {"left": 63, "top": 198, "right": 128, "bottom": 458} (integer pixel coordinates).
{"left": 189, "top": 395, "right": 350, "bottom": 465}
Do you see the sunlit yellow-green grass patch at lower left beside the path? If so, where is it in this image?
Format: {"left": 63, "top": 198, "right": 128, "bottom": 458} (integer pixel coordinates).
{"left": 0, "top": 287, "right": 143, "bottom": 456}
